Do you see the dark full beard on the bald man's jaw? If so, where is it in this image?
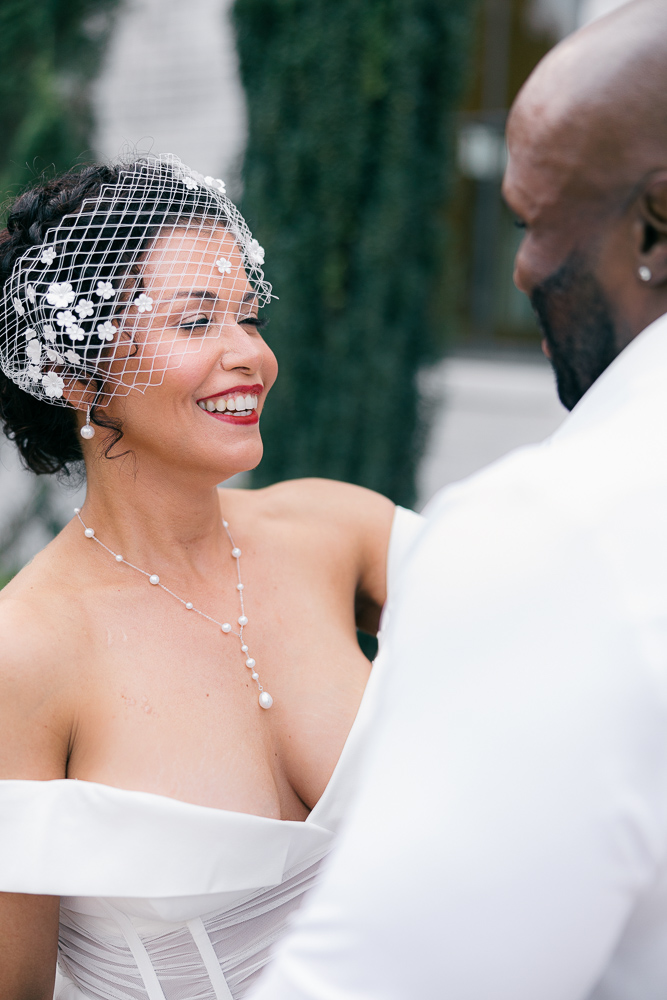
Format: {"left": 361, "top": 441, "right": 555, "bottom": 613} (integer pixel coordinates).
{"left": 530, "top": 254, "right": 620, "bottom": 410}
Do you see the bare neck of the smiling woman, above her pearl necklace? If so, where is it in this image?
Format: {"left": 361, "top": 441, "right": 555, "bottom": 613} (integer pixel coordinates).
{"left": 82, "top": 457, "right": 231, "bottom": 574}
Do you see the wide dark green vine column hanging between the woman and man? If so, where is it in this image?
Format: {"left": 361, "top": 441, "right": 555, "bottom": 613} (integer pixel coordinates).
{"left": 234, "top": 0, "right": 474, "bottom": 504}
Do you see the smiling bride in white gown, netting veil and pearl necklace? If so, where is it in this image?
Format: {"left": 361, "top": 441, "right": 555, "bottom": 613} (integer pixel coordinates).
{"left": 0, "top": 156, "right": 420, "bottom": 1000}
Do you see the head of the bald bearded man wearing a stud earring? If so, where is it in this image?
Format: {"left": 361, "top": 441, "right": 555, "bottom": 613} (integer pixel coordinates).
{"left": 503, "top": 0, "right": 667, "bottom": 409}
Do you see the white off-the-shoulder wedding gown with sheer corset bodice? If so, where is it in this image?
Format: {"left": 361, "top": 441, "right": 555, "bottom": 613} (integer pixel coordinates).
{"left": 0, "top": 508, "right": 423, "bottom": 1000}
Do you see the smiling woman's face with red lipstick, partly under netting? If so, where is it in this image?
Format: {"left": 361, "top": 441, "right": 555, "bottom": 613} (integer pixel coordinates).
{"left": 97, "top": 227, "right": 278, "bottom": 481}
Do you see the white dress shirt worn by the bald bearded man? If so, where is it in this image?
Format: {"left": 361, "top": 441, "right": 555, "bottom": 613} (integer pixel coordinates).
{"left": 252, "top": 316, "right": 667, "bottom": 1000}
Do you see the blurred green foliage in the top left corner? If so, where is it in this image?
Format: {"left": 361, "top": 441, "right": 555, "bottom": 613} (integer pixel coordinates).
{"left": 0, "top": 0, "right": 118, "bottom": 207}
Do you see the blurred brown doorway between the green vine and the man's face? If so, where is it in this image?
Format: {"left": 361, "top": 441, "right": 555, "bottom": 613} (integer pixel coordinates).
{"left": 447, "top": 0, "right": 627, "bottom": 354}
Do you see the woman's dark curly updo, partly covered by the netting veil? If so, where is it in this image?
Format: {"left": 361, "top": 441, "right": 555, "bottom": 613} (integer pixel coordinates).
{"left": 0, "top": 159, "right": 226, "bottom": 475}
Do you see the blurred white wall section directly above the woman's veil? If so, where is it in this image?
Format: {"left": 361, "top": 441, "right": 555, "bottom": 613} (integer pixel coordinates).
{"left": 94, "top": 0, "right": 246, "bottom": 190}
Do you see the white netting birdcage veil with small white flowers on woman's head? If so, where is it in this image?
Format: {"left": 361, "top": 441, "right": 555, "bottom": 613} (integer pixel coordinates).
{"left": 0, "top": 155, "right": 271, "bottom": 408}
